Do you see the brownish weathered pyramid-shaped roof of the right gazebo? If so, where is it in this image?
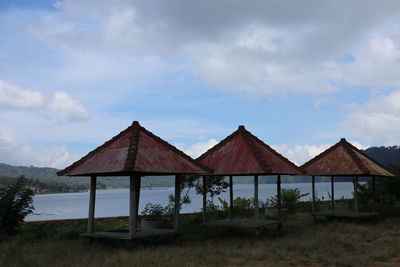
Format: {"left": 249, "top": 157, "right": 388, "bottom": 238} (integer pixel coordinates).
{"left": 300, "top": 138, "right": 394, "bottom": 176}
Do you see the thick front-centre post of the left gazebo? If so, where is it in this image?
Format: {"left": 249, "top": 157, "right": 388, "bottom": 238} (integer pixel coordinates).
{"left": 129, "top": 175, "right": 141, "bottom": 238}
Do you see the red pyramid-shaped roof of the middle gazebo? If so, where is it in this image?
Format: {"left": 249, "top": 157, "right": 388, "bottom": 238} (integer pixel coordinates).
{"left": 196, "top": 126, "right": 302, "bottom": 175}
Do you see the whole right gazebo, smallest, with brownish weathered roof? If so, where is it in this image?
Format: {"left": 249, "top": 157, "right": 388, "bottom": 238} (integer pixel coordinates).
{"left": 300, "top": 138, "right": 394, "bottom": 218}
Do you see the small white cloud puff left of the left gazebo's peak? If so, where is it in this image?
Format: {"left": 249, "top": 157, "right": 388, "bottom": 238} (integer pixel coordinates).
{"left": 49, "top": 91, "right": 89, "bottom": 120}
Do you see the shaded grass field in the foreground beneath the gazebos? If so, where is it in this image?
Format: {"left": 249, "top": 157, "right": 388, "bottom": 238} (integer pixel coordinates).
{"left": 0, "top": 213, "right": 400, "bottom": 266}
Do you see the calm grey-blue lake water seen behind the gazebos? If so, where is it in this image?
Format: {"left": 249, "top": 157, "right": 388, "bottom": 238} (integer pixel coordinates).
{"left": 26, "top": 182, "right": 360, "bottom": 221}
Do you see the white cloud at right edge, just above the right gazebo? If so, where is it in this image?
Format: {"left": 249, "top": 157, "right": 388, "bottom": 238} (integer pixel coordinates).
{"left": 344, "top": 90, "right": 400, "bottom": 145}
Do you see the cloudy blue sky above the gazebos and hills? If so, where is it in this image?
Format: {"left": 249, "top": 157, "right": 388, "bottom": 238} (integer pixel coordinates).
{"left": 0, "top": 0, "right": 400, "bottom": 168}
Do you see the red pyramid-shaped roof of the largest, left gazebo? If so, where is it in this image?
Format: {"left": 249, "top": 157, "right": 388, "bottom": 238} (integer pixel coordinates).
{"left": 57, "top": 121, "right": 210, "bottom": 176}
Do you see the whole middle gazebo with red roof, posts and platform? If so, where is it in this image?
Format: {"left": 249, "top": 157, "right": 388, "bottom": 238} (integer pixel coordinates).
{"left": 196, "top": 126, "right": 302, "bottom": 233}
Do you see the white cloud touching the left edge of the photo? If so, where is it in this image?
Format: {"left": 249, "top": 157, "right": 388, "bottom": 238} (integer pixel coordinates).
{"left": 0, "top": 80, "right": 44, "bottom": 109}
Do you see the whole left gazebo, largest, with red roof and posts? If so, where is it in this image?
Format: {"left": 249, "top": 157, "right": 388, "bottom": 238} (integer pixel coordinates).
{"left": 57, "top": 121, "right": 209, "bottom": 239}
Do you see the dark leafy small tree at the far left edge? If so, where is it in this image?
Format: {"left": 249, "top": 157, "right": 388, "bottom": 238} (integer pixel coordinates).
{"left": 0, "top": 176, "right": 34, "bottom": 235}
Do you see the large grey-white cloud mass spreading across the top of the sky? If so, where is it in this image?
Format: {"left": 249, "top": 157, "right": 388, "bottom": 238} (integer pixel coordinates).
{"left": 30, "top": 0, "right": 400, "bottom": 97}
